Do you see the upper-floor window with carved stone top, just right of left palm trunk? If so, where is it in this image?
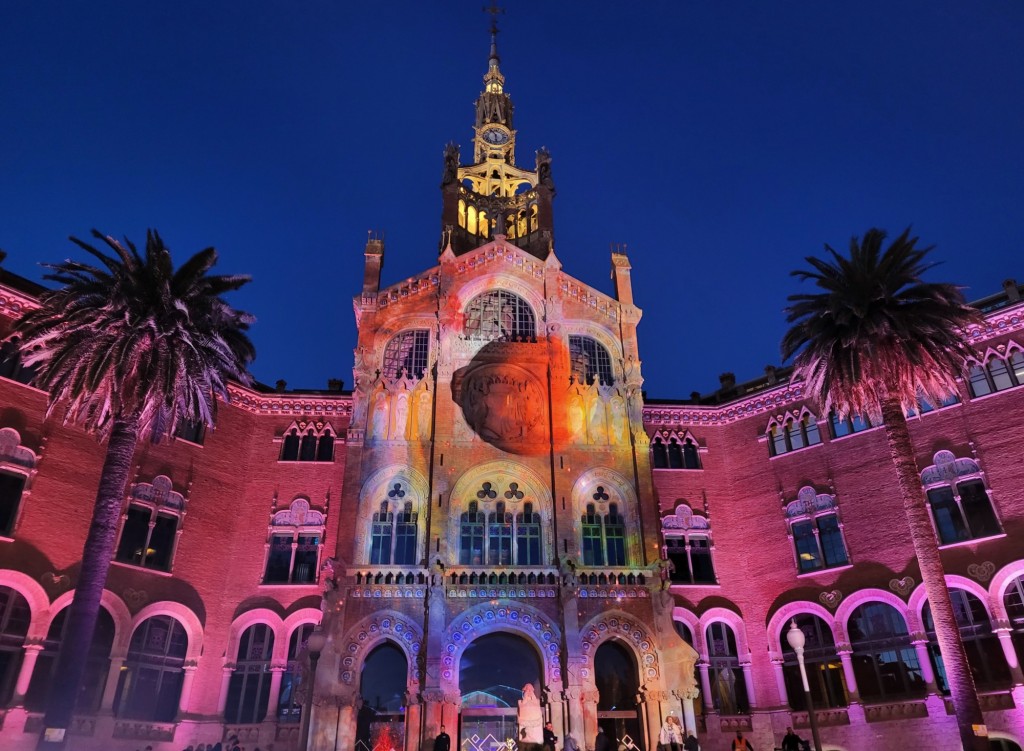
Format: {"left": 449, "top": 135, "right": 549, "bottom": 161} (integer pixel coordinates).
{"left": 115, "top": 474, "right": 185, "bottom": 571}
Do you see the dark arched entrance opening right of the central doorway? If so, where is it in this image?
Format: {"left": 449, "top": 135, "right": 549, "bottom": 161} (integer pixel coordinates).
{"left": 594, "top": 641, "right": 644, "bottom": 749}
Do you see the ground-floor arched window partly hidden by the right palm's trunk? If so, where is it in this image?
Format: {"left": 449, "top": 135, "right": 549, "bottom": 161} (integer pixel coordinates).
{"left": 921, "top": 589, "right": 1012, "bottom": 694}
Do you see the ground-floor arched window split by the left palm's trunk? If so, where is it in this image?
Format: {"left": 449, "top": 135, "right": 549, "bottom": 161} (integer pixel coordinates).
{"left": 25, "top": 608, "right": 114, "bottom": 714}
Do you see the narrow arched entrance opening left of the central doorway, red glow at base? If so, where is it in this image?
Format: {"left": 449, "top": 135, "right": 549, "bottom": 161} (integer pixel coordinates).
{"left": 355, "top": 641, "right": 409, "bottom": 751}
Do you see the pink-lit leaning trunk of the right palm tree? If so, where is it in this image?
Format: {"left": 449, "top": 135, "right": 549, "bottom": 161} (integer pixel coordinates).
{"left": 882, "top": 390, "right": 988, "bottom": 751}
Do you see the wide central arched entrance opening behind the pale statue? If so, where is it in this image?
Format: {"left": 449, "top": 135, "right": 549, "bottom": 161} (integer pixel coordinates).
{"left": 459, "top": 633, "right": 544, "bottom": 751}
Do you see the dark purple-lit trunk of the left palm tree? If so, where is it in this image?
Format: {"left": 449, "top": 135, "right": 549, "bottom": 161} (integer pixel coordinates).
{"left": 38, "top": 417, "right": 138, "bottom": 749}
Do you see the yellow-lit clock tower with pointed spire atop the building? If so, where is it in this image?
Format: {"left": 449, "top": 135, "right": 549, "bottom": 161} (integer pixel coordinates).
{"left": 440, "top": 23, "right": 555, "bottom": 259}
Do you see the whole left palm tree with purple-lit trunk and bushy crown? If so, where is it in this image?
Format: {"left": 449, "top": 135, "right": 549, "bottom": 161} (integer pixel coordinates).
{"left": 16, "top": 231, "right": 254, "bottom": 747}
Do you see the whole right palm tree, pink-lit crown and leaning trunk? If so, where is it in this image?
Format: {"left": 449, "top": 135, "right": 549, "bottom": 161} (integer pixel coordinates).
{"left": 782, "top": 227, "right": 988, "bottom": 751}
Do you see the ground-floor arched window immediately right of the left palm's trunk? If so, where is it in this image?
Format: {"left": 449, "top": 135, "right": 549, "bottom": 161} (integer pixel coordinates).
{"left": 114, "top": 616, "right": 188, "bottom": 722}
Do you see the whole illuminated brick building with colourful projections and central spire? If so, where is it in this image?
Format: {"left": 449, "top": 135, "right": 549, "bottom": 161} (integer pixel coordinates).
{"left": 0, "top": 20, "right": 1024, "bottom": 751}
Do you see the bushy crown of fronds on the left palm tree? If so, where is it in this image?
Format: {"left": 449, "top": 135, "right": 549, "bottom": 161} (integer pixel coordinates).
{"left": 16, "top": 231, "right": 255, "bottom": 432}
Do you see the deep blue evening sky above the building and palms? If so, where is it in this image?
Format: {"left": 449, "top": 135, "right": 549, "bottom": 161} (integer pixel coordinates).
{"left": 0, "top": 0, "right": 1024, "bottom": 398}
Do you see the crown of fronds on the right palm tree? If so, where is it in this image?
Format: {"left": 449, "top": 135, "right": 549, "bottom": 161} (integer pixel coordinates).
{"left": 781, "top": 227, "right": 982, "bottom": 418}
